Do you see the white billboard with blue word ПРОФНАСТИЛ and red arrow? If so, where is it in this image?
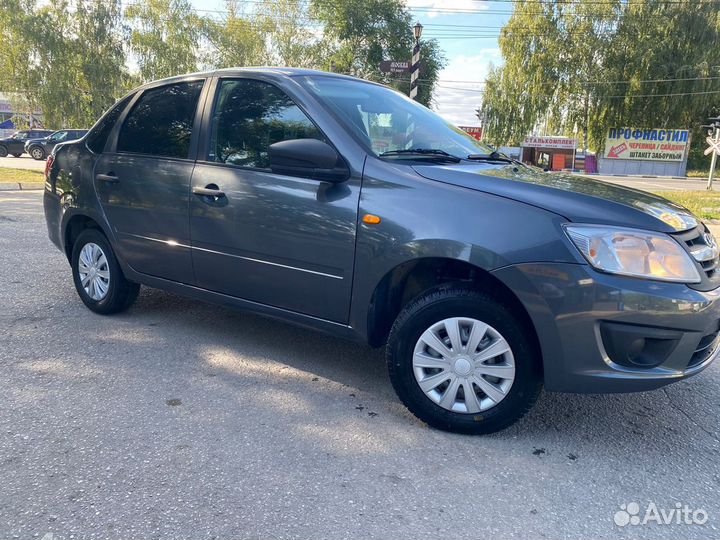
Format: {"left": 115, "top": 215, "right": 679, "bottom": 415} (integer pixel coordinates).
{"left": 604, "top": 128, "right": 690, "bottom": 161}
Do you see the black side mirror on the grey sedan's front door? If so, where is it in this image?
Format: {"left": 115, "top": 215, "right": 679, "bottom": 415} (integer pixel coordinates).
{"left": 268, "top": 139, "right": 350, "bottom": 183}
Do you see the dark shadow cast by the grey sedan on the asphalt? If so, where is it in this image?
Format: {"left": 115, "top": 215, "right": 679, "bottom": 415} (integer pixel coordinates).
{"left": 109, "top": 288, "right": 718, "bottom": 445}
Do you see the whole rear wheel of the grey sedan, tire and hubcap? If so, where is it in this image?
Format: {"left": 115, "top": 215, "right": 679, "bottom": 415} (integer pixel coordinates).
{"left": 71, "top": 229, "right": 140, "bottom": 315}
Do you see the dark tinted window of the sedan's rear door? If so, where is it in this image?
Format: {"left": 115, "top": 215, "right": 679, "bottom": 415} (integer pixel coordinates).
{"left": 117, "top": 81, "right": 203, "bottom": 158}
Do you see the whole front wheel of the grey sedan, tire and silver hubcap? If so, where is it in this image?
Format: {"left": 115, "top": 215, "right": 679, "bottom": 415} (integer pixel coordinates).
{"left": 387, "top": 285, "right": 542, "bottom": 435}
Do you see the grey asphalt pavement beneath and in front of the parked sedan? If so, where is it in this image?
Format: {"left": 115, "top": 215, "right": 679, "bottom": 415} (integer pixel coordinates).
{"left": 0, "top": 192, "right": 720, "bottom": 540}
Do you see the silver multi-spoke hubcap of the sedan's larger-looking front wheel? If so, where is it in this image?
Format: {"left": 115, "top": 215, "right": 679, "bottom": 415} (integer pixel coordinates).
{"left": 413, "top": 317, "right": 515, "bottom": 413}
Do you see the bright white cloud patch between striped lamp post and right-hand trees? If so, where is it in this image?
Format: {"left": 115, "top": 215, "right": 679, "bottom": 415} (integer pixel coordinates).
{"left": 433, "top": 48, "right": 502, "bottom": 126}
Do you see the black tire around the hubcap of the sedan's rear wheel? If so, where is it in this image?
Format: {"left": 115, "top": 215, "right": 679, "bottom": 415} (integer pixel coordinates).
{"left": 70, "top": 229, "right": 140, "bottom": 315}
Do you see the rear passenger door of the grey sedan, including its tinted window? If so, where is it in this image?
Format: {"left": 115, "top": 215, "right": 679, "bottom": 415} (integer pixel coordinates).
{"left": 95, "top": 80, "right": 204, "bottom": 283}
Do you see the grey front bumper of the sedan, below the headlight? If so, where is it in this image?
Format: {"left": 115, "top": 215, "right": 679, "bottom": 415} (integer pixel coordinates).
{"left": 494, "top": 263, "right": 720, "bottom": 393}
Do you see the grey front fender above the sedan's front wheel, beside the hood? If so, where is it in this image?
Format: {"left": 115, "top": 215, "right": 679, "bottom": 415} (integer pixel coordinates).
{"left": 350, "top": 159, "right": 578, "bottom": 339}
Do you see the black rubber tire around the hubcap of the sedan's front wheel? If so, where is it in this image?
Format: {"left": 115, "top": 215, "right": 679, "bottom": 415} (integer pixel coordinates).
{"left": 386, "top": 285, "right": 542, "bottom": 435}
